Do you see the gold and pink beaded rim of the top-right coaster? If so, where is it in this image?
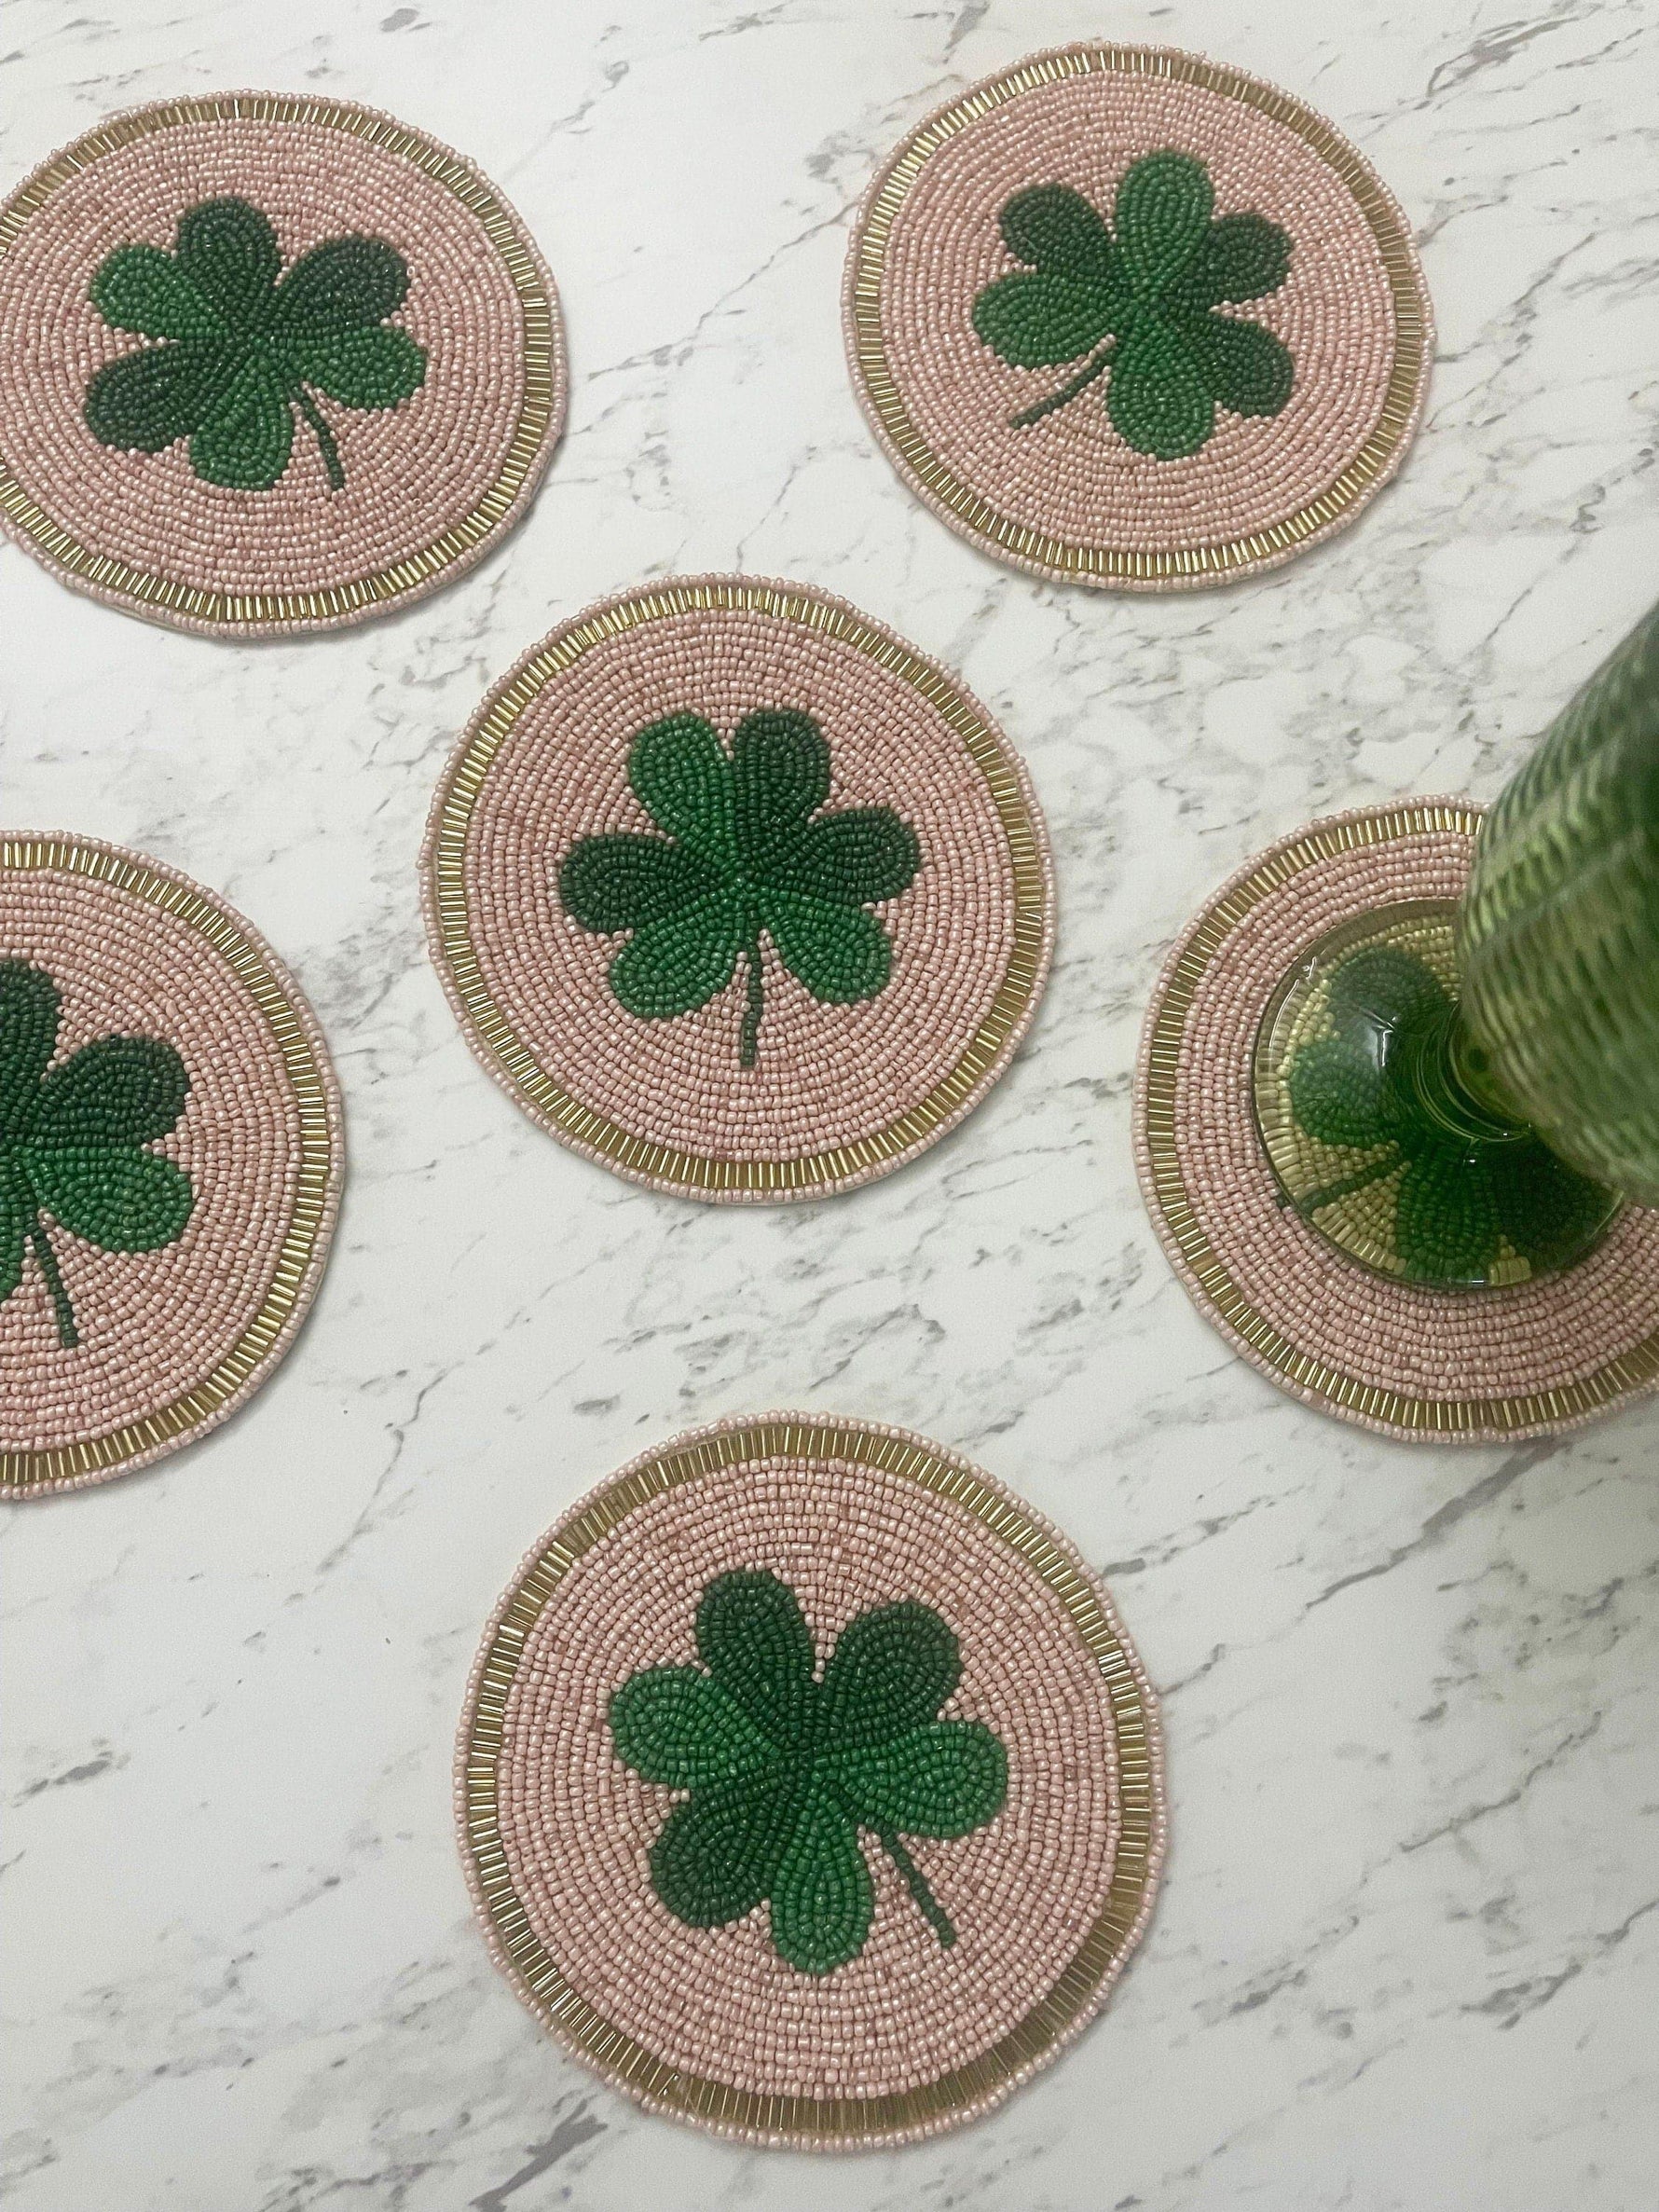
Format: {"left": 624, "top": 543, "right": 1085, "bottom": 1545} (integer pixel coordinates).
{"left": 843, "top": 47, "right": 1433, "bottom": 591}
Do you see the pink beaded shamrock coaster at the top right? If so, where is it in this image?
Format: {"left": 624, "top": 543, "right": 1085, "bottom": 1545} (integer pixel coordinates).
{"left": 845, "top": 47, "right": 1433, "bottom": 591}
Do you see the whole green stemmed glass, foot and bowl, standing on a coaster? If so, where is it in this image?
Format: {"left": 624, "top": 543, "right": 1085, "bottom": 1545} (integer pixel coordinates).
{"left": 1255, "top": 609, "right": 1659, "bottom": 1287}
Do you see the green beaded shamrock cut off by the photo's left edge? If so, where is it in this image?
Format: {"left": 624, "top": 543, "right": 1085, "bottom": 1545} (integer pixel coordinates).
{"left": 0, "top": 960, "right": 195, "bottom": 1347}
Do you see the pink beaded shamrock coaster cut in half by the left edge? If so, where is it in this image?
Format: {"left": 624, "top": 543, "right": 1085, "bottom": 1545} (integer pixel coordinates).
{"left": 0, "top": 836, "right": 343, "bottom": 1498}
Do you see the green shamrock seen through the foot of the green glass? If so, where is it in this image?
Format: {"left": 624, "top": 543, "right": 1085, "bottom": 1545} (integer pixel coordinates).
{"left": 1287, "top": 944, "right": 1606, "bottom": 1283}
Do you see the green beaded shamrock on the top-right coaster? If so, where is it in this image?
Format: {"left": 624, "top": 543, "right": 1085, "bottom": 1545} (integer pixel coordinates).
{"left": 973, "top": 150, "right": 1296, "bottom": 460}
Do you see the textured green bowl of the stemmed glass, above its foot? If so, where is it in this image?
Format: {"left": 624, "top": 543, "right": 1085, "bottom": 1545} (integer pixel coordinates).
{"left": 1458, "top": 609, "right": 1659, "bottom": 1205}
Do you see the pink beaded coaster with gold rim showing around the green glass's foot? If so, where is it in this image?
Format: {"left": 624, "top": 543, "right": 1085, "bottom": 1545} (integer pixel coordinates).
{"left": 1135, "top": 799, "right": 1659, "bottom": 1442}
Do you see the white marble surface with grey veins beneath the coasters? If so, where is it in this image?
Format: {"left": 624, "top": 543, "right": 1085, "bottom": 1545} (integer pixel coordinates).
{"left": 0, "top": 0, "right": 1659, "bottom": 2212}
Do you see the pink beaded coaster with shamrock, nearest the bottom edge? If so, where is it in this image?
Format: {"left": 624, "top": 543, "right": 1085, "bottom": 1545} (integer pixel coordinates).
{"left": 456, "top": 1413, "right": 1163, "bottom": 2150}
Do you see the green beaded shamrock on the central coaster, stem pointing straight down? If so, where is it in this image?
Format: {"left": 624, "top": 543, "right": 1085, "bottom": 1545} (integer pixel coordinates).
{"left": 559, "top": 708, "right": 920, "bottom": 1068}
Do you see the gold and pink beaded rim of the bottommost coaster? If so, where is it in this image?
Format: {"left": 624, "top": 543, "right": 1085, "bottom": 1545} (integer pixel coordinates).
{"left": 456, "top": 1413, "right": 1166, "bottom": 2150}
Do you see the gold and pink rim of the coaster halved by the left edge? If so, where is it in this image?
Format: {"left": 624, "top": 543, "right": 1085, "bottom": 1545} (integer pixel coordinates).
{"left": 0, "top": 836, "right": 345, "bottom": 1498}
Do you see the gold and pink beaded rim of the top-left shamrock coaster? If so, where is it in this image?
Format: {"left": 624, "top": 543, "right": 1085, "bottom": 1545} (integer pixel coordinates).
{"left": 0, "top": 93, "right": 567, "bottom": 637}
